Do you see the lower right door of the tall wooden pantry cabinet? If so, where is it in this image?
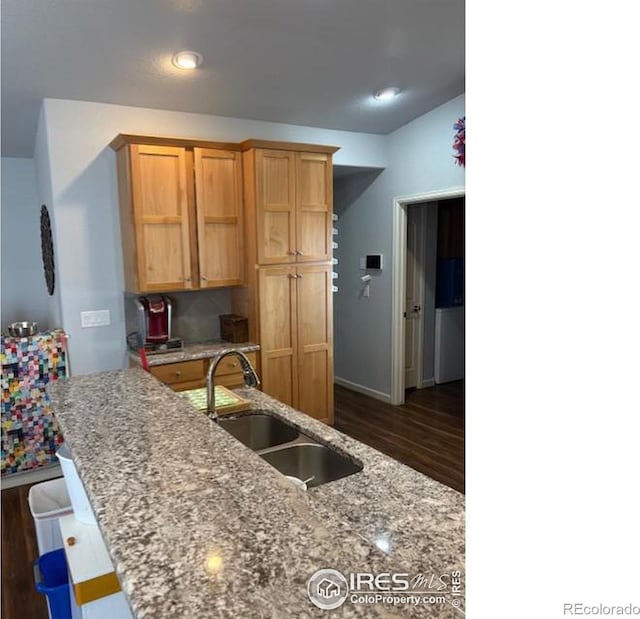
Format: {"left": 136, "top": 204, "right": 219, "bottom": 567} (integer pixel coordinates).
{"left": 295, "top": 265, "right": 333, "bottom": 423}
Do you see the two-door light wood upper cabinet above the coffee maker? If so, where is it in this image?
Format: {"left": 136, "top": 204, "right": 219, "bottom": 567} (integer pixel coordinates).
{"left": 112, "top": 136, "right": 244, "bottom": 292}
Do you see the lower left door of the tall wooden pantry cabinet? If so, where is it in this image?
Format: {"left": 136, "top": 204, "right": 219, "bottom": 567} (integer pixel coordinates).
{"left": 258, "top": 267, "right": 298, "bottom": 407}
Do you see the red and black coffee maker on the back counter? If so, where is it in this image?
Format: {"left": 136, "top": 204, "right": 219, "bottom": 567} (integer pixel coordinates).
{"left": 129, "top": 295, "right": 183, "bottom": 353}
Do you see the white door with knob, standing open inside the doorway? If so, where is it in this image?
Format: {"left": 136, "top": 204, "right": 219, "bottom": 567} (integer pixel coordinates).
{"left": 404, "top": 211, "right": 425, "bottom": 389}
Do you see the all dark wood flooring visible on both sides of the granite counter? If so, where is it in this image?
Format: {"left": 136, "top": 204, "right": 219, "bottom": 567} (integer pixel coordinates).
{"left": 2, "top": 381, "right": 464, "bottom": 619}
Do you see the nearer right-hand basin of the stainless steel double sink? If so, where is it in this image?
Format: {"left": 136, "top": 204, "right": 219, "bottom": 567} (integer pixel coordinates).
{"left": 260, "top": 443, "right": 362, "bottom": 488}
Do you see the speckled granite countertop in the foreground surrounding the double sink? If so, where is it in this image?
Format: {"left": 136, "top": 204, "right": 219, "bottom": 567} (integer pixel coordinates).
{"left": 49, "top": 369, "right": 464, "bottom": 619}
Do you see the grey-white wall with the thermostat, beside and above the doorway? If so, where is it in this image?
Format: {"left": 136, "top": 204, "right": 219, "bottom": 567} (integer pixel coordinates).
{"left": 334, "top": 95, "right": 464, "bottom": 398}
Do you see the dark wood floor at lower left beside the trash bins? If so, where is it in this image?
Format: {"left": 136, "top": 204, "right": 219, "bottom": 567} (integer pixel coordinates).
{"left": 1, "top": 486, "right": 49, "bottom": 619}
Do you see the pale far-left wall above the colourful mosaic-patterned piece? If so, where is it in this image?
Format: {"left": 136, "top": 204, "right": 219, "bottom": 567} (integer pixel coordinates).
{"left": 1, "top": 157, "right": 51, "bottom": 330}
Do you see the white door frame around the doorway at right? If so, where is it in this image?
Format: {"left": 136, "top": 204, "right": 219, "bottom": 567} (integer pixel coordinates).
{"left": 391, "top": 187, "right": 465, "bottom": 405}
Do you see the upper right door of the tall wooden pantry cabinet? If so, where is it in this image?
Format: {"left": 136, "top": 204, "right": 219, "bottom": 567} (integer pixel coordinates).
{"left": 294, "top": 153, "right": 333, "bottom": 262}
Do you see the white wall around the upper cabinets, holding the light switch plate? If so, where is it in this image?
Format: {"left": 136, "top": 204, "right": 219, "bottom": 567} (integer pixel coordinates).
{"left": 37, "top": 99, "right": 387, "bottom": 374}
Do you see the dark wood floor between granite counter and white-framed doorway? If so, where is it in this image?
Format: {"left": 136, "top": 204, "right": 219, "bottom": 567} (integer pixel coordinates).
{"left": 334, "top": 381, "right": 464, "bottom": 492}
